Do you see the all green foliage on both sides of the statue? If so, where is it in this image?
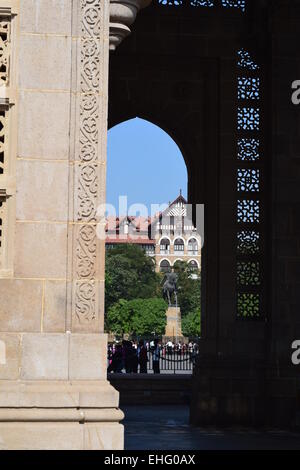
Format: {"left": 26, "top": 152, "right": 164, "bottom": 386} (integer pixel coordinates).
{"left": 105, "top": 244, "right": 201, "bottom": 336}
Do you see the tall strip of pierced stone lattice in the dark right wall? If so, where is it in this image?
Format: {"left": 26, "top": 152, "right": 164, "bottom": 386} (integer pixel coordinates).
{"left": 236, "top": 49, "right": 264, "bottom": 319}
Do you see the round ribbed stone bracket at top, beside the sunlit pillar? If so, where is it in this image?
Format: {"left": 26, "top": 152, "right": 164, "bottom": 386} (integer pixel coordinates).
{"left": 109, "top": 0, "right": 152, "bottom": 51}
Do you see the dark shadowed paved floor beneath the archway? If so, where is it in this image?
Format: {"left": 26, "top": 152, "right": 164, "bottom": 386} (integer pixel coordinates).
{"left": 122, "top": 406, "right": 300, "bottom": 450}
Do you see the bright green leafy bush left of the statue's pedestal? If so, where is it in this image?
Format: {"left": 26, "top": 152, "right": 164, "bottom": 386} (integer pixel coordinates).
{"left": 106, "top": 298, "right": 167, "bottom": 336}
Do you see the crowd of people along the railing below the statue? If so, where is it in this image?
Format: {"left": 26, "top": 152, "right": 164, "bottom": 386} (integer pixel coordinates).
{"left": 107, "top": 339, "right": 198, "bottom": 374}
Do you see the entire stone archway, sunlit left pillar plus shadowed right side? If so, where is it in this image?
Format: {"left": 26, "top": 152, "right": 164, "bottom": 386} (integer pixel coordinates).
{"left": 0, "top": 0, "right": 300, "bottom": 449}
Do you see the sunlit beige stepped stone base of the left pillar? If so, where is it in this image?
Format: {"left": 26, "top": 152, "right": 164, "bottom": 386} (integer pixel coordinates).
{"left": 0, "top": 380, "right": 124, "bottom": 450}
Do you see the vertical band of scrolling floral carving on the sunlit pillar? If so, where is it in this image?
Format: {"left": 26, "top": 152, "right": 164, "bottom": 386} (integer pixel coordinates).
{"left": 75, "top": 0, "right": 103, "bottom": 323}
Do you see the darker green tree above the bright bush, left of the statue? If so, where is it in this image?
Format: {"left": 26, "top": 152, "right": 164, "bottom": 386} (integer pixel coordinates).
{"left": 105, "top": 244, "right": 159, "bottom": 311}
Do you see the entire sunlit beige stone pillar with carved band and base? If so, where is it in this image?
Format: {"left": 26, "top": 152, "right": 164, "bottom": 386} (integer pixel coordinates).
{"left": 0, "top": 0, "right": 123, "bottom": 450}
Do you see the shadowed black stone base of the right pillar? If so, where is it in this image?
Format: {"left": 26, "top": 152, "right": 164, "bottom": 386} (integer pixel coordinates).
{"left": 191, "top": 358, "right": 297, "bottom": 428}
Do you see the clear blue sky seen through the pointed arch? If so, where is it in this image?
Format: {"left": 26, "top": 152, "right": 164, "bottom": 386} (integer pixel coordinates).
{"left": 106, "top": 118, "right": 187, "bottom": 215}
